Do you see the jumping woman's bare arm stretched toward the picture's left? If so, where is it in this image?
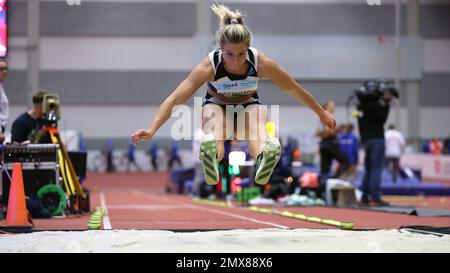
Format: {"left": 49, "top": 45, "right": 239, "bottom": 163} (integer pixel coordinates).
{"left": 131, "top": 58, "right": 214, "bottom": 144}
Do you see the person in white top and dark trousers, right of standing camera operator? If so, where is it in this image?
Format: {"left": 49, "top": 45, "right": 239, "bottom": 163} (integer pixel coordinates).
{"left": 384, "top": 124, "right": 406, "bottom": 182}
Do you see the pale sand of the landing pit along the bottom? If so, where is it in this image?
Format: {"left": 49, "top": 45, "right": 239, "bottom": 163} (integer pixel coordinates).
{"left": 0, "top": 226, "right": 450, "bottom": 253}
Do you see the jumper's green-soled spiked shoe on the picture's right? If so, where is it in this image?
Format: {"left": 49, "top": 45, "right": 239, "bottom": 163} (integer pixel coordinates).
{"left": 255, "top": 137, "right": 281, "bottom": 185}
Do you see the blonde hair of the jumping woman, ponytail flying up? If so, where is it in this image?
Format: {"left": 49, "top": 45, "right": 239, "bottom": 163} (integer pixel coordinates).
{"left": 211, "top": 4, "right": 252, "bottom": 47}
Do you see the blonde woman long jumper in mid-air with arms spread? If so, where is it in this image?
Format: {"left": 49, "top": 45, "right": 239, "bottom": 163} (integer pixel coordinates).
{"left": 131, "top": 5, "right": 336, "bottom": 185}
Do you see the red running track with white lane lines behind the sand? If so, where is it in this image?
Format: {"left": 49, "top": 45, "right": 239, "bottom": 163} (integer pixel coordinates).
{"left": 0, "top": 172, "right": 450, "bottom": 231}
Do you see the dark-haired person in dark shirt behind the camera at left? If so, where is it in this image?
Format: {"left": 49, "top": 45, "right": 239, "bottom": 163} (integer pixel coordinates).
{"left": 11, "top": 90, "right": 51, "bottom": 143}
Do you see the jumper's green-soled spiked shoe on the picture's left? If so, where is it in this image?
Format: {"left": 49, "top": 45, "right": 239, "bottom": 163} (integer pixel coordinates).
{"left": 200, "top": 135, "right": 219, "bottom": 185}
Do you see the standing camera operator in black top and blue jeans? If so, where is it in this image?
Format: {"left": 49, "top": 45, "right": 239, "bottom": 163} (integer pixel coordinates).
{"left": 356, "top": 81, "right": 398, "bottom": 206}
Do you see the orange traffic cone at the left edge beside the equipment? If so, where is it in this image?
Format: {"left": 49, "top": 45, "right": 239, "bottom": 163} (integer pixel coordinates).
{"left": 6, "top": 163, "right": 30, "bottom": 227}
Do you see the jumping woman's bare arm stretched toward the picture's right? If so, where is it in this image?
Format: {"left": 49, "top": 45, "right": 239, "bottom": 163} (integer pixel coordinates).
{"left": 258, "top": 52, "right": 336, "bottom": 129}
